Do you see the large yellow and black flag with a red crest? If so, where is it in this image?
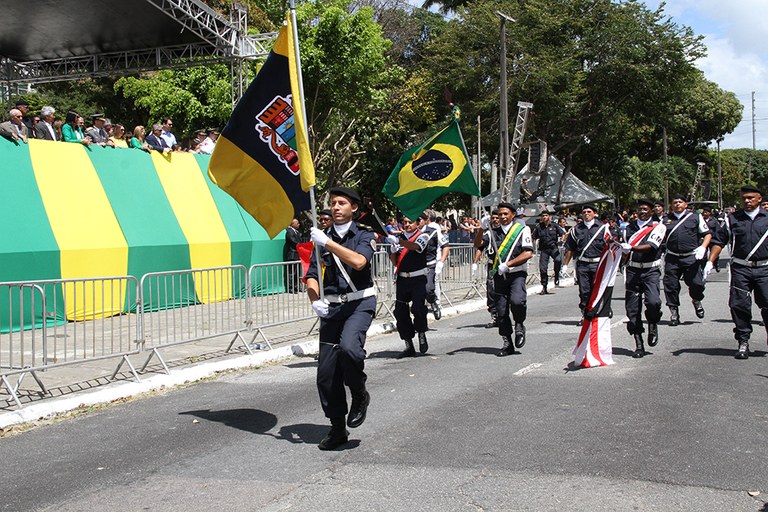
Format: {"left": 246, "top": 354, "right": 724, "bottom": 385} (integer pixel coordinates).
{"left": 208, "top": 16, "right": 315, "bottom": 238}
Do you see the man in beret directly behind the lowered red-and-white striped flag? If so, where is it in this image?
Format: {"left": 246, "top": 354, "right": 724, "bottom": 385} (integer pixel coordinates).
{"left": 565, "top": 204, "right": 611, "bottom": 325}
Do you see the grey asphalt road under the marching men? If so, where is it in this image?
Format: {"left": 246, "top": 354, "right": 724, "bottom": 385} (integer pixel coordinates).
{"left": 0, "top": 273, "right": 768, "bottom": 512}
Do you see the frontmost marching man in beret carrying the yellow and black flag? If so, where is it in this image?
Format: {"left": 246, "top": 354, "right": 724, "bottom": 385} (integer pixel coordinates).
{"left": 306, "top": 187, "right": 376, "bottom": 450}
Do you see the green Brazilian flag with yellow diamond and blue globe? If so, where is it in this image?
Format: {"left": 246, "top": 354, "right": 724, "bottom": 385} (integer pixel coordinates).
{"left": 383, "top": 108, "right": 480, "bottom": 219}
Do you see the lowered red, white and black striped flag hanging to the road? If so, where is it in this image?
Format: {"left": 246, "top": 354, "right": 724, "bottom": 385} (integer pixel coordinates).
{"left": 573, "top": 243, "right": 621, "bottom": 368}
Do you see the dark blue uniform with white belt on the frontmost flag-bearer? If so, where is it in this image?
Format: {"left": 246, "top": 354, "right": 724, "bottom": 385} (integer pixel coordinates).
{"left": 306, "top": 222, "right": 376, "bottom": 419}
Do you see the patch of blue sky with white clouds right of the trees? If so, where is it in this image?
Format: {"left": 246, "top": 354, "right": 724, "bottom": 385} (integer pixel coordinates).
{"left": 644, "top": 0, "right": 768, "bottom": 149}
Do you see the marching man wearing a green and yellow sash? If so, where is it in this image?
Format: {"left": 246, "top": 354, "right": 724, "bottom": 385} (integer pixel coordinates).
{"left": 491, "top": 203, "right": 533, "bottom": 357}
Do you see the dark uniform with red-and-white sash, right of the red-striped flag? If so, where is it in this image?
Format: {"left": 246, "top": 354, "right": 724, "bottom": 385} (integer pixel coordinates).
{"left": 624, "top": 219, "right": 666, "bottom": 335}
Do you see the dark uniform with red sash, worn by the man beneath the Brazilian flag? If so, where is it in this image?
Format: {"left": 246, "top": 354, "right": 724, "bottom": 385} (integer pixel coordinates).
{"left": 394, "top": 231, "right": 429, "bottom": 342}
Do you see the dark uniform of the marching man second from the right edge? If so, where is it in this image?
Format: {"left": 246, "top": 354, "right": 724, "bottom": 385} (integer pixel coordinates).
{"left": 664, "top": 212, "right": 709, "bottom": 310}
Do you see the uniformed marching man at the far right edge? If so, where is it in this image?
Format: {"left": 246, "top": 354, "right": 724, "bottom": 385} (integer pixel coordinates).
{"left": 704, "top": 186, "right": 768, "bottom": 359}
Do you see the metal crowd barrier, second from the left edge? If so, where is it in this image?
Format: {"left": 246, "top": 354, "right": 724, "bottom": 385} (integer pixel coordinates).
{"left": 139, "top": 265, "right": 251, "bottom": 373}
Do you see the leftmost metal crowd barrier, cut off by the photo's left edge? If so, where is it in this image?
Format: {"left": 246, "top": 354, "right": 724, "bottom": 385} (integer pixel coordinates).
{"left": 0, "top": 276, "right": 141, "bottom": 407}
